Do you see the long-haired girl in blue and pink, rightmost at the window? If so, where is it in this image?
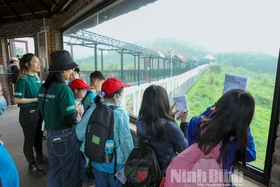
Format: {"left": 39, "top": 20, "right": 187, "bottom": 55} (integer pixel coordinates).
{"left": 165, "top": 89, "right": 255, "bottom": 187}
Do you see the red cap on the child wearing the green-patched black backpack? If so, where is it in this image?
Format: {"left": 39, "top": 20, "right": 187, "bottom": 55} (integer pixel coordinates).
{"left": 102, "top": 77, "right": 130, "bottom": 95}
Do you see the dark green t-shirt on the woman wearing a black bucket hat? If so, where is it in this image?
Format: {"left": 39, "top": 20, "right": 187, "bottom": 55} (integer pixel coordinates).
{"left": 38, "top": 82, "right": 77, "bottom": 130}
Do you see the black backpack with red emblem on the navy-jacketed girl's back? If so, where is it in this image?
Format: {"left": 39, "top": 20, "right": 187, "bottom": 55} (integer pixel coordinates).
{"left": 124, "top": 140, "right": 163, "bottom": 187}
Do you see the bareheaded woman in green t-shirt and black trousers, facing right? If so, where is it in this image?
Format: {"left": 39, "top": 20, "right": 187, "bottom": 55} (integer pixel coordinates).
{"left": 14, "top": 53, "right": 48, "bottom": 176}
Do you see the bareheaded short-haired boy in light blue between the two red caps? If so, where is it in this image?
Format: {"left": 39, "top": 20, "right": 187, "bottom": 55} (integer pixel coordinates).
{"left": 82, "top": 71, "right": 105, "bottom": 110}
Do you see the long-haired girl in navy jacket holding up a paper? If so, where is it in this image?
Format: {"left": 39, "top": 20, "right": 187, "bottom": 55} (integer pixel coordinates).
{"left": 136, "top": 85, "right": 188, "bottom": 171}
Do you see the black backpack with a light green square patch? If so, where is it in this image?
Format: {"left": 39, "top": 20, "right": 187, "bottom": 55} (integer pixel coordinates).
{"left": 85, "top": 104, "right": 117, "bottom": 163}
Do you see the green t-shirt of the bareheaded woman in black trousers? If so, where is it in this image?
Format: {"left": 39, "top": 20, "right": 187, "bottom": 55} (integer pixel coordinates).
{"left": 14, "top": 75, "right": 42, "bottom": 108}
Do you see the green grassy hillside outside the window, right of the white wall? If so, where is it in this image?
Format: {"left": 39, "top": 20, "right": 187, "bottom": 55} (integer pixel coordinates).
{"left": 187, "top": 67, "right": 275, "bottom": 169}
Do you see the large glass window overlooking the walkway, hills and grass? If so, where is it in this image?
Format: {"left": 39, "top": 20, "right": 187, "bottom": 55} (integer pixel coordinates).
{"left": 63, "top": 0, "right": 280, "bottom": 170}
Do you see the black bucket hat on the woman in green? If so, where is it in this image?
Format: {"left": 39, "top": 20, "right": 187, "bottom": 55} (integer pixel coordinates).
{"left": 48, "top": 50, "right": 78, "bottom": 72}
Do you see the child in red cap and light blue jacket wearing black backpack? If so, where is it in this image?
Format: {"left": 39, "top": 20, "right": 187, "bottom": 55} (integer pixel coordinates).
{"left": 76, "top": 78, "right": 134, "bottom": 187}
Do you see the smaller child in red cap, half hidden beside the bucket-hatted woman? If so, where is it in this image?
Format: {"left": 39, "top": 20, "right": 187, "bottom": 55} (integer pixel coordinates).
{"left": 69, "top": 78, "right": 92, "bottom": 121}
